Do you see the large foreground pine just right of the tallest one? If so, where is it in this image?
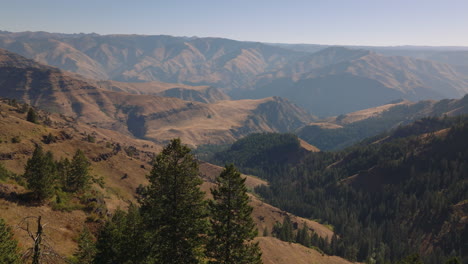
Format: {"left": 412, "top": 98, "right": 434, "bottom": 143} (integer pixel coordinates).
{"left": 208, "top": 164, "right": 262, "bottom": 264}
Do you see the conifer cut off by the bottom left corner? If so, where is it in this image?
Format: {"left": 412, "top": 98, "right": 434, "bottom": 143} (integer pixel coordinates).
{"left": 0, "top": 218, "right": 20, "bottom": 264}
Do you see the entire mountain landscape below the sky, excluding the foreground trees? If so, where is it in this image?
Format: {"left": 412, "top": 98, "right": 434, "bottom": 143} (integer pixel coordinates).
{"left": 0, "top": 31, "right": 468, "bottom": 263}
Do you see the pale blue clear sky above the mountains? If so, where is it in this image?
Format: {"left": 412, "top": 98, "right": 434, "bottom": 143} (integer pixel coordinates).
{"left": 0, "top": 0, "right": 468, "bottom": 46}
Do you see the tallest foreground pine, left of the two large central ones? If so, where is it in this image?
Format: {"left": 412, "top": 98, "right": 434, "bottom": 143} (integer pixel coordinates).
{"left": 141, "top": 139, "right": 207, "bottom": 264}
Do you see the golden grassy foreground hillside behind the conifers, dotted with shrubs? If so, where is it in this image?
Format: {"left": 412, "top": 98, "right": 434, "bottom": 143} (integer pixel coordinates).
{"left": 0, "top": 99, "right": 338, "bottom": 264}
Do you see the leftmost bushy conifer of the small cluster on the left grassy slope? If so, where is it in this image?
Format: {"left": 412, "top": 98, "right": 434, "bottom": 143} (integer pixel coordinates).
{"left": 24, "top": 145, "right": 56, "bottom": 201}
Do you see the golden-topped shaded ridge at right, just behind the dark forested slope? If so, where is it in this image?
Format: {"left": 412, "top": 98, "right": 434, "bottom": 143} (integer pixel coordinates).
{"left": 295, "top": 96, "right": 468, "bottom": 150}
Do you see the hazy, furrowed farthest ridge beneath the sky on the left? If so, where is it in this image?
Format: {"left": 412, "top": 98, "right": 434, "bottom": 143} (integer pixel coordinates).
{"left": 0, "top": 32, "right": 302, "bottom": 88}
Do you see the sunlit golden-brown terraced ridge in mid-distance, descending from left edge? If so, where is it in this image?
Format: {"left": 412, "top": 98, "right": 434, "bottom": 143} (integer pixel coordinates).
{"left": 0, "top": 50, "right": 314, "bottom": 146}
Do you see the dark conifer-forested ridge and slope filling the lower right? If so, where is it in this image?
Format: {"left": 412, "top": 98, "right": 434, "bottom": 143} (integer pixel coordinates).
{"left": 209, "top": 120, "right": 468, "bottom": 264}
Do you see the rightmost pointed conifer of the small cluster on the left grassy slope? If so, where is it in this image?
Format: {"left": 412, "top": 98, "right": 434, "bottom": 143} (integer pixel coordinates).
{"left": 66, "top": 150, "right": 91, "bottom": 192}
